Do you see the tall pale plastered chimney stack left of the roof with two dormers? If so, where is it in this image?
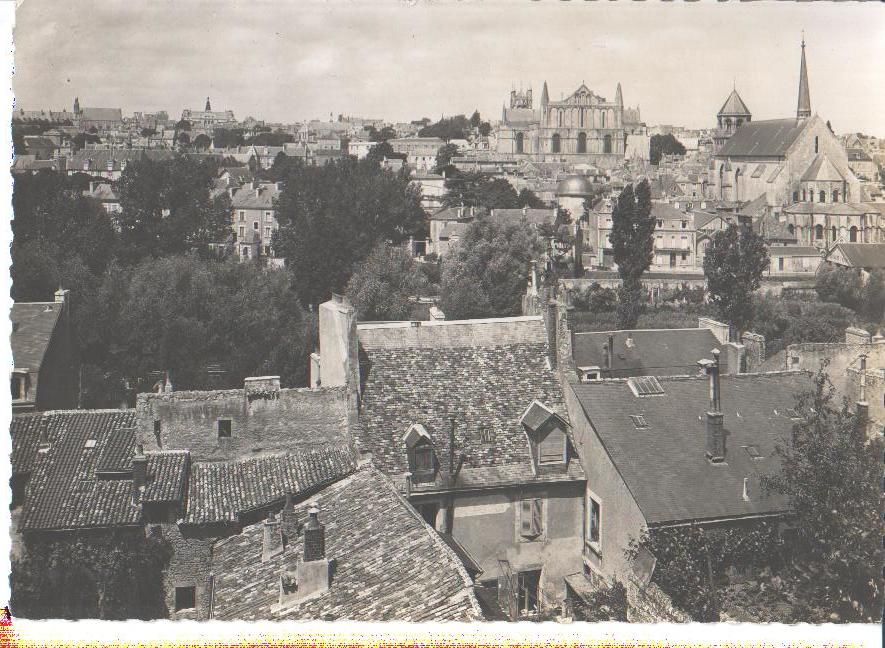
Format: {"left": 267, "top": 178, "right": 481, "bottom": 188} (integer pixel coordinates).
{"left": 319, "top": 294, "right": 360, "bottom": 392}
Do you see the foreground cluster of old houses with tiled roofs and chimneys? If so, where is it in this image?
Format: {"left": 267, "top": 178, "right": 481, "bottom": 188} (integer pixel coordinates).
{"left": 12, "top": 290, "right": 885, "bottom": 620}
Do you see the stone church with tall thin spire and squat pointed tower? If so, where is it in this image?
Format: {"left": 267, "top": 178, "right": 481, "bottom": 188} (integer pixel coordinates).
{"left": 707, "top": 34, "right": 885, "bottom": 249}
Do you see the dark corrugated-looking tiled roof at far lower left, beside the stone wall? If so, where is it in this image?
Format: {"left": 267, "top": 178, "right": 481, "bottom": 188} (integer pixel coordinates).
{"left": 20, "top": 410, "right": 187, "bottom": 531}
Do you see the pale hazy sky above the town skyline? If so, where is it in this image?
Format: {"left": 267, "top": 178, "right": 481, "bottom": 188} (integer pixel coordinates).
{"left": 13, "top": 0, "right": 885, "bottom": 137}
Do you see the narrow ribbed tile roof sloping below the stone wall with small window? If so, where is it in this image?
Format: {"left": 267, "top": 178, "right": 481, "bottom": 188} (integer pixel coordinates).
{"left": 186, "top": 446, "right": 355, "bottom": 524}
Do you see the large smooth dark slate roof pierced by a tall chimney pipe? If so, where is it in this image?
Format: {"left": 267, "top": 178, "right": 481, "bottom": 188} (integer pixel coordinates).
{"left": 571, "top": 372, "right": 812, "bottom": 524}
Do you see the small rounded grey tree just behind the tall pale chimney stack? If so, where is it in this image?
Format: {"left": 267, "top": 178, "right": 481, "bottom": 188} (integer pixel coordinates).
{"left": 345, "top": 243, "right": 429, "bottom": 320}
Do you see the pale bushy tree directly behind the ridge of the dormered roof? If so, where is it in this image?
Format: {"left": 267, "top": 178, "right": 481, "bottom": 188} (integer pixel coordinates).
{"left": 440, "top": 217, "right": 542, "bottom": 319}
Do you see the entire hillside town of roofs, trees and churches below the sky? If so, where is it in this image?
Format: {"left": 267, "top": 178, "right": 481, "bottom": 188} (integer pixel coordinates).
{"left": 10, "top": 8, "right": 885, "bottom": 623}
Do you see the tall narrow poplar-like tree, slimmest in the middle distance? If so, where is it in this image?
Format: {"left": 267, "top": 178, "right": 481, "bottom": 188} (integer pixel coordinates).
{"left": 610, "top": 180, "right": 655, "bottom": 329}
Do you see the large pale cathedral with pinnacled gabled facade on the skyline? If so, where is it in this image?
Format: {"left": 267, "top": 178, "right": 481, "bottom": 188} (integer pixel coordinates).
{"left": 497, "top": 81, "right": 639, "bottom": 168}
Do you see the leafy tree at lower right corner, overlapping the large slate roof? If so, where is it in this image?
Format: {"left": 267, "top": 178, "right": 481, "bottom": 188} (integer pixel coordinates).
{"left": 763, "top": 366, "right": 885, "bottom": 622}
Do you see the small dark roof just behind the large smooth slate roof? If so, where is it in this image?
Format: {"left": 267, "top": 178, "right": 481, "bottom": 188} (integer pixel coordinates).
{"left": 572, "top": 328, "right": 725, "bottom": 378}
